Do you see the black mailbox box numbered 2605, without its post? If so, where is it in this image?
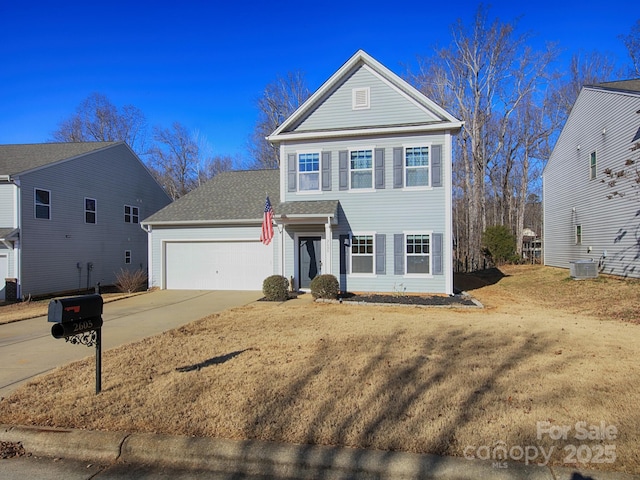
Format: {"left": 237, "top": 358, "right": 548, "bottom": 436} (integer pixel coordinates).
{"left": 49, "top": 294, "right": 103, "bottom": 338}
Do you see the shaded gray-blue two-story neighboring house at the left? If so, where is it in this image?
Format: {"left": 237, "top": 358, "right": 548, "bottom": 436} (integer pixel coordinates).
{"left": 0, "top": 142, "right": 171, "bottom": 300}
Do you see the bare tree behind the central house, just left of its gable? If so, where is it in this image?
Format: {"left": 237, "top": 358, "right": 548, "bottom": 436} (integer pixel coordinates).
{"left": 249, "top": 72, "right": 310, "bottom": 168}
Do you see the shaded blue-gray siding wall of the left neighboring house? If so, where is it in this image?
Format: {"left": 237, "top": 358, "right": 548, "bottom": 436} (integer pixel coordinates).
{"left": 20, "top": 144, "right": 170, "bottom": 295}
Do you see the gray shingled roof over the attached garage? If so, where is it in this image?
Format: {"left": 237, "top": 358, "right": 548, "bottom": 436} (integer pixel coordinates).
{"left": 141, "top": 170, "right": 280, "bottom": 225}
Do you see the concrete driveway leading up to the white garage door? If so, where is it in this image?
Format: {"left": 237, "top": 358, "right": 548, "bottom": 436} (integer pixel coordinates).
{"left": 0, "top": 290, "right": 262, "bottom": 398}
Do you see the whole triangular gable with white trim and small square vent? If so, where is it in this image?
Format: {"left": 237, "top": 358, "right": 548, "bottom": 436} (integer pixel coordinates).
{"left": 268, "top": 50, "right": 462, "bottom": 143}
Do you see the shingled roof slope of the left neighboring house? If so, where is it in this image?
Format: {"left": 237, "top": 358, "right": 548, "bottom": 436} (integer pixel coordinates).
{"left": 0, "top": 142, "right": 117, "bottom": 175}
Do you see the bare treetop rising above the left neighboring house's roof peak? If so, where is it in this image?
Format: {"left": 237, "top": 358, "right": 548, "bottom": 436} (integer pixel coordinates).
{"left": 52, "top": 93, "right": 146, "bottom": 155}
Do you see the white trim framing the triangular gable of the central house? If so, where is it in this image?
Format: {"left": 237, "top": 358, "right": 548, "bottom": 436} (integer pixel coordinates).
{"left": 267, "top": 50, "right": 463, "bottom": 143}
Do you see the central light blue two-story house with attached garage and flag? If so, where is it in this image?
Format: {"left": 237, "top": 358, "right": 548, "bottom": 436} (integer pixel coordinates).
{"left": 143, "top": 51, "right": 462, "bottom": 294}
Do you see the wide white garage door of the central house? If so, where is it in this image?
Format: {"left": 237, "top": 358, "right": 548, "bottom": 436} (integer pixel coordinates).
{"left": 165, "top": 241, "right": 273, "bottom": 290}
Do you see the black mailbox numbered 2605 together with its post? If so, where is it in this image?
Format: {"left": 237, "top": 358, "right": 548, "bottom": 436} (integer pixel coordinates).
{"left": 48, "top": 294, "right": 104, "bottom": 394}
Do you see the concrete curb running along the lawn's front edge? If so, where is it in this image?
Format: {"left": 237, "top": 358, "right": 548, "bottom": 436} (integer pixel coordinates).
{"left": 0, "top": 425, "right": 640, "bottom": 480}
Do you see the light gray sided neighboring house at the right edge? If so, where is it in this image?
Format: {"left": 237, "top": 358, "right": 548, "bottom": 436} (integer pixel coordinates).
{"left": 543, "top": 79, "right": 640, "bottom": 277}
